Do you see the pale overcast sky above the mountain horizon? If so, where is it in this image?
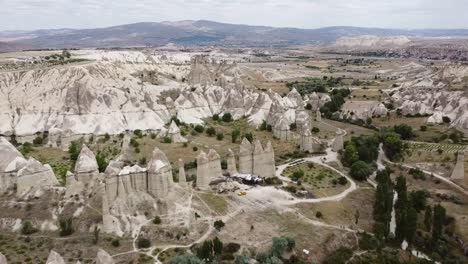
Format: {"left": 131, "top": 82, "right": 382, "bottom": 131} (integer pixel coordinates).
{"left": 0, "top": 0, "right": 468, "bottom": 30}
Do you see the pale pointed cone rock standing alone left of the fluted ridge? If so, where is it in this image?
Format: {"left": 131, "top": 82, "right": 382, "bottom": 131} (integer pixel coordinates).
{"left": 75, "top": 144, "right": 99, "bottom": 183}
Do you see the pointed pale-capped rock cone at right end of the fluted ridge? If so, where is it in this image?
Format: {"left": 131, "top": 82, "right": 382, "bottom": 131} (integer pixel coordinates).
{"left": 147, "top": 148, "right": 173, "bottom": 198}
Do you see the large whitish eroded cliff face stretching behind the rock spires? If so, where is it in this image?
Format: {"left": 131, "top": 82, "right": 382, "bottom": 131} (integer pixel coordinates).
{"left": 0, "top": 51, "right": 314, "bottom": 137}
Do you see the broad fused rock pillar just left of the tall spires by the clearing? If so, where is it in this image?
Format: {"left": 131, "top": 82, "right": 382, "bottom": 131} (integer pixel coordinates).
{"left": 197, "top": 149, "right": 222, "bottom": 190}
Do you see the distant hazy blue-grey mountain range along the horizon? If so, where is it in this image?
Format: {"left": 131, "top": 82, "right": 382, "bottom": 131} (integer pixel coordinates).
{"left": 0, "top": 20, "right": 468, "bottom": 50}
